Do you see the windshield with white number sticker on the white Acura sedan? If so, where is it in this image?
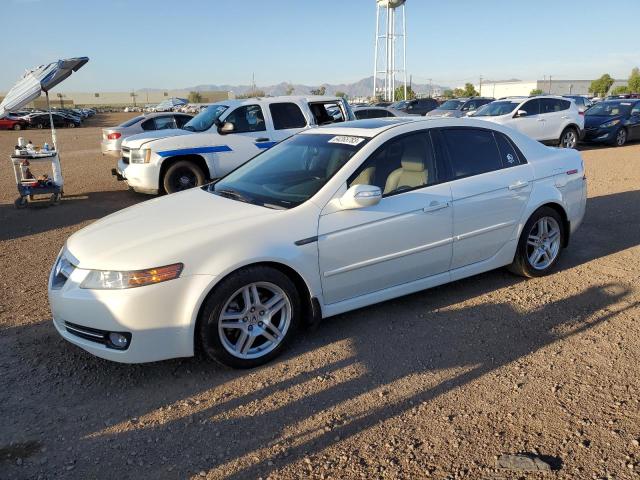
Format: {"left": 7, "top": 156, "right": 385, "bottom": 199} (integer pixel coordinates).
{"left": 205, "top": 134, "right": 367, "bottom": 208}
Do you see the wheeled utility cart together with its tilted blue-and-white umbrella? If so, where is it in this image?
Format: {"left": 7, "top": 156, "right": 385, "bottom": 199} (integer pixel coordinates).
{"left": 0, "top": 57, "right": 89, "bottom": 208}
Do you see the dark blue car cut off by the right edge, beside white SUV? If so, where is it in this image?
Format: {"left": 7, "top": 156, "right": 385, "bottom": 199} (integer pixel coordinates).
{"left": 584, "top": 99, "right": 640, "bottom": 147}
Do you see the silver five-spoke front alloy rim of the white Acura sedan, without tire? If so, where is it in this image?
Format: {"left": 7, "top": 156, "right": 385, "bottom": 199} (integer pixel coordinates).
{"left": 218, "top": 282, "right": 292, "bottom": 359}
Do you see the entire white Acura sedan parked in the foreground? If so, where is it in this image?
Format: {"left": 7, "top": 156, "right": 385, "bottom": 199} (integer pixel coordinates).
{"left": 49, "top": 118, "right": 586, "bottom": 367}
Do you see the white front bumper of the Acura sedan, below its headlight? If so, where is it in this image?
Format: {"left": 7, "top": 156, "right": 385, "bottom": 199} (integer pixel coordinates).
{"left": 49, "top": 262, "right": 214, "bottom": 363}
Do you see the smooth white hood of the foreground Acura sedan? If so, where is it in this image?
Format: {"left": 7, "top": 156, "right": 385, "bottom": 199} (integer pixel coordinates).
{"left": 66, "top": 188, "right": 284, "bottom": 273}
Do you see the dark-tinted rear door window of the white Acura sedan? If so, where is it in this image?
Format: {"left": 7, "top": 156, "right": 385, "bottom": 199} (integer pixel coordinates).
{"left": 442, "top": 128, "right": 502, "bottom": 178}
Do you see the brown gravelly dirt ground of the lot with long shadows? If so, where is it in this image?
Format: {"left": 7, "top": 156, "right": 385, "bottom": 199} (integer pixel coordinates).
{"left": 0, "top": 115, "right": 640, "bottom": 479}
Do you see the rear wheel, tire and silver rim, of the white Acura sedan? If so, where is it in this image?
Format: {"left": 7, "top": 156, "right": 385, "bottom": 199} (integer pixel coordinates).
{"left": 507, "top": 207, "right": 566, "bottom": 278}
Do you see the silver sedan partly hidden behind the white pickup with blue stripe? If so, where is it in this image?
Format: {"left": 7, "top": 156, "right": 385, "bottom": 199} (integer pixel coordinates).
{"left": 100, "top": 113, "right": 193, "bottom": 157}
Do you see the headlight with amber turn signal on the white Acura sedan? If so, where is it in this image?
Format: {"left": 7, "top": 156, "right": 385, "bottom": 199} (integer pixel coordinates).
{"left": 80, "top": 263, "right": 184, "bottom": 290}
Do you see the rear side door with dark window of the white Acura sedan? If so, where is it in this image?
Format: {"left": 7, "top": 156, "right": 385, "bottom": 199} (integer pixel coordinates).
{"left": 438, "top": 127, "right": 533, "bottom": 270}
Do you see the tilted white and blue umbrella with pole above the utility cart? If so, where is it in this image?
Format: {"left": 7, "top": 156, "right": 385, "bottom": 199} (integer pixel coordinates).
{"left": 0, "top": 57, "right": 89, "bottom": 151}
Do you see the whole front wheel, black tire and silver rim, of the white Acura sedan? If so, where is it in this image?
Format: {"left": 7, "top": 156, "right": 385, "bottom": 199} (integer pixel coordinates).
{"left": 196, "top": 266, "right": 301, "bottom": 368}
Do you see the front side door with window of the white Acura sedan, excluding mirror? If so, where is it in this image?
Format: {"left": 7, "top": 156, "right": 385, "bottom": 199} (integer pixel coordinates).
{"left": 318, "top": 132, "right": 453, "bottom": 304}
